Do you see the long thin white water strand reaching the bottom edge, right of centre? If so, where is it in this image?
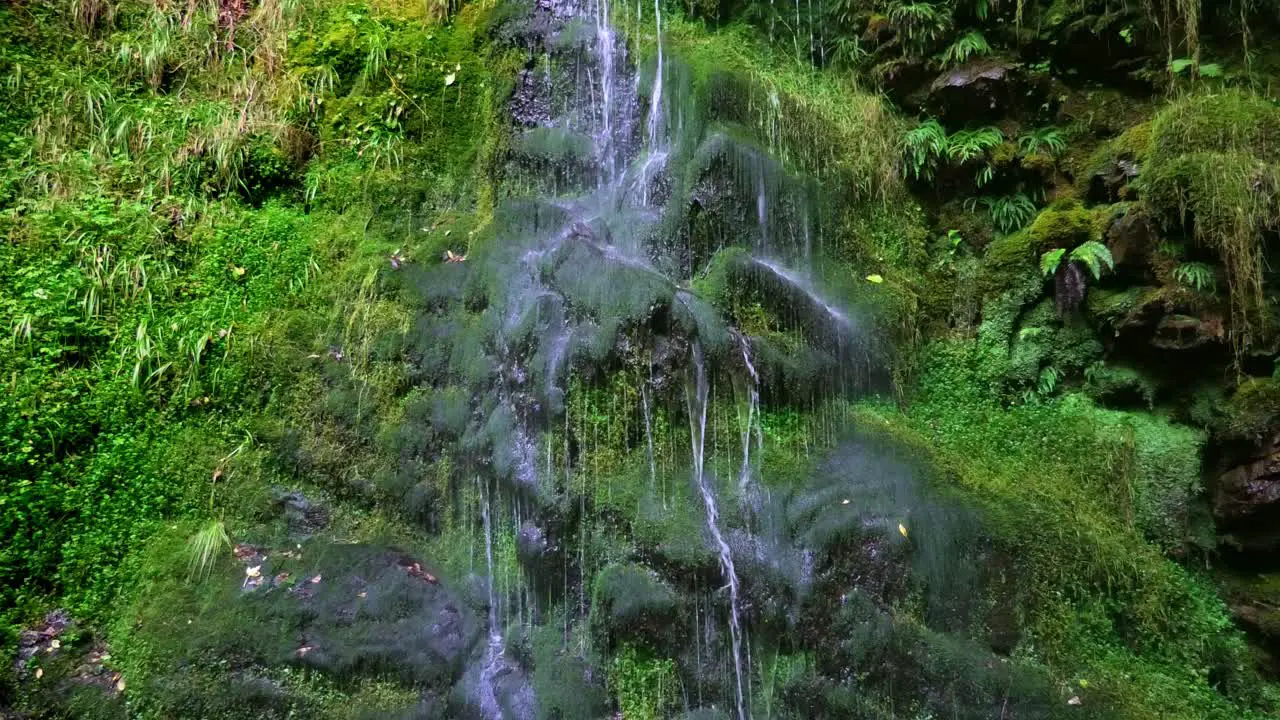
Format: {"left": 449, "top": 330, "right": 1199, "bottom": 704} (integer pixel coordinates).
{"left": 685, "top": 341, "right": 746, "bottom": 720}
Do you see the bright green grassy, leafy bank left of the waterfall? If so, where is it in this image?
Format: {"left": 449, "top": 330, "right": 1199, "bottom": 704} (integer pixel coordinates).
{"left": 0, "top": 1, "right": 512, "bottom": 666}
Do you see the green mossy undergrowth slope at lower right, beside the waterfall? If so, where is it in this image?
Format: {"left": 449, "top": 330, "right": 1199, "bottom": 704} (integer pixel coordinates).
{"left": 860, "top": 341, "right": 1274, "bottom": 719}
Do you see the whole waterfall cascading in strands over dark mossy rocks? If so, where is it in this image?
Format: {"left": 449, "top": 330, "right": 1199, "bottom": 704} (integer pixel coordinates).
{"left": 438, "top": 0, "right": 890, "bottom": 720}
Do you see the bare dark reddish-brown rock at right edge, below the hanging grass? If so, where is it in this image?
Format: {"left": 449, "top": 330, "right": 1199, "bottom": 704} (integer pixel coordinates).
{"left": 1213, "top": 434, "right": 1280, "bottom": 553}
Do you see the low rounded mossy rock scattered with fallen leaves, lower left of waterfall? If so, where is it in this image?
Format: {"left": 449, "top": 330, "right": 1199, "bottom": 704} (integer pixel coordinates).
{"left": 110, "top": 534, "right": 483, "bottom": 717}
